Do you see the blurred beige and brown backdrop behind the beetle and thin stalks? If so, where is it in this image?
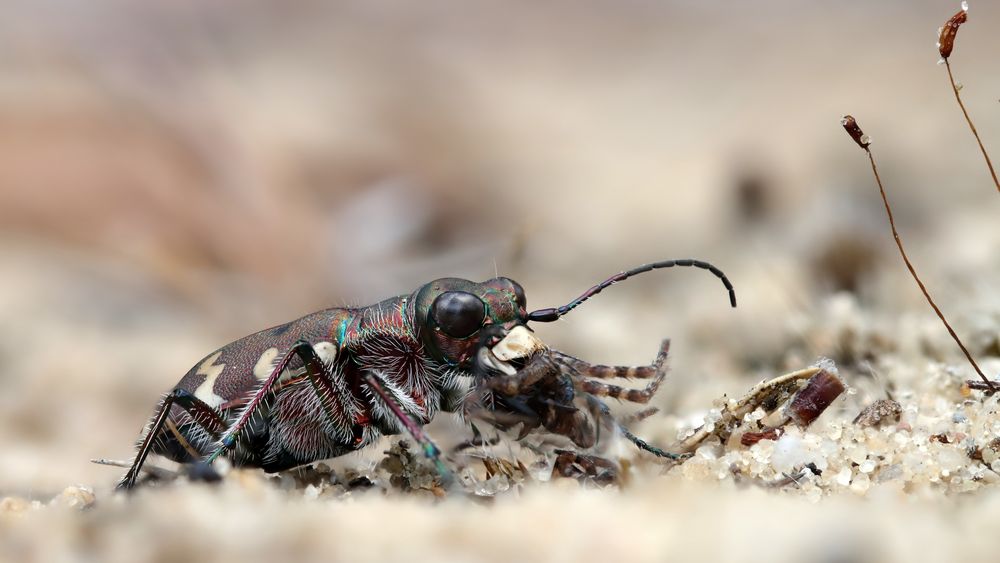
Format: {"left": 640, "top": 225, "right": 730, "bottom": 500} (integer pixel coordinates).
{"left": 0, "top": 0, "right": 1000, "bottom": 495}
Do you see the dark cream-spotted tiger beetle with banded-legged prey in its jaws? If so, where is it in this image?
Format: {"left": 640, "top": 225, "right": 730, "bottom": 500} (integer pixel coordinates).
{"left": 118, "top": 259, "right": 736, "bottom": 489}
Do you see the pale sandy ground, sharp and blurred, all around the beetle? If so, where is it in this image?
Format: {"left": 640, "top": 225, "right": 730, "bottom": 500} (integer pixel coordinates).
{"left": 0, "top": 0, "right": 1000, "bottom": 562}
